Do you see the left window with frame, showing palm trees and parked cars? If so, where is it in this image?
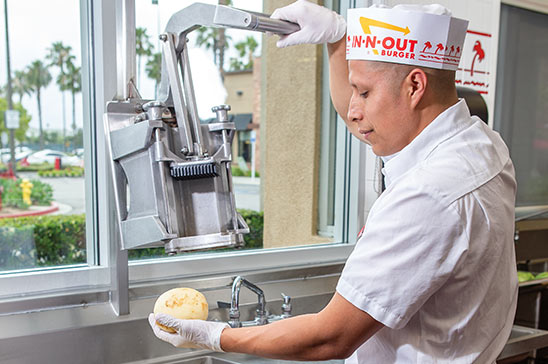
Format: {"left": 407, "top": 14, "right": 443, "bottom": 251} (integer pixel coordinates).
{"left": 0, "top": 0, "right": 109, "bottom": 302}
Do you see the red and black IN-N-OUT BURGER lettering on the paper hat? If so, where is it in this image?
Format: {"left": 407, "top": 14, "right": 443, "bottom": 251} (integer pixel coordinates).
{"left": 351, "top": 35, "right": 418, "bottom": 59}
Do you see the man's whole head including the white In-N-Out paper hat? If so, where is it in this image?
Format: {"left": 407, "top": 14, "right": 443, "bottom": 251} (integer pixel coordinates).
{"left": 346, "top": 5, "right": 468, "bottom": 156}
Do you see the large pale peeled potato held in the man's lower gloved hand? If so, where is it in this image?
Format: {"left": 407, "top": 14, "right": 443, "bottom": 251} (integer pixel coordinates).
{"left": 154, "top": 288, "right": 208, "bottom": 333}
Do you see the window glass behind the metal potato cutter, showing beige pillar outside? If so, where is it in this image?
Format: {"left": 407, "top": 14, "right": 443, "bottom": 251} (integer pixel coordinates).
{"left": 129, "top": 0, "right": 343, "bottom": 259}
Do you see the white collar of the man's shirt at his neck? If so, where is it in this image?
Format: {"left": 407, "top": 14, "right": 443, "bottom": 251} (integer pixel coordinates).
{"left": 382, "top": 99, "right": 472, "bottom": 187}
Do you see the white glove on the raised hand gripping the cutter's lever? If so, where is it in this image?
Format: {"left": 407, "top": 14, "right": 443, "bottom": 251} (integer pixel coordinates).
{"left": 270, "top": 0, "right": 346, "bottom": 48}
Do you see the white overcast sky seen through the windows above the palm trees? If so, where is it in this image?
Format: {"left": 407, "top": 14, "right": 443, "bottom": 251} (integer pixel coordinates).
{"left": 0, "top": 0, "right": 262, "bottom": 136}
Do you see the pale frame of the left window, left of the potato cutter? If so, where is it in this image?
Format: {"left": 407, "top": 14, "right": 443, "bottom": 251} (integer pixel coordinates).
{"left": 0, "top": 0, "right": 114, "bottom": 300}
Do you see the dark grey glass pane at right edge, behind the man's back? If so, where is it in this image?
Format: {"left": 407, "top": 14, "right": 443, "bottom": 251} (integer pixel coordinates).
{"left": 494, "top": 4, "right": 548, "bottom": 206}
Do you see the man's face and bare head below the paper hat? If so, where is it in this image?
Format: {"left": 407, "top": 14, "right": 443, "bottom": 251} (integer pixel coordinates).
{"left": 347, "top": 60, "right": 458, "bottom": 156}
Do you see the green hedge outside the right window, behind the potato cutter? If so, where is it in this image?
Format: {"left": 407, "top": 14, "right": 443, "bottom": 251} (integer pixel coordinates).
{"left": 128, "top": 209, "right": 264, "bottom": 259}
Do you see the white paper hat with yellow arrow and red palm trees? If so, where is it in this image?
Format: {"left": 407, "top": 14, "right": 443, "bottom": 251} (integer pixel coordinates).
{"left": 346, "top": 4, "right": 468, "bottom": 71}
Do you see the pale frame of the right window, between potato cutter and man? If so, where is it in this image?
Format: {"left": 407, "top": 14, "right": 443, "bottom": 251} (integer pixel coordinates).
{"left": 126, "top": 0, "right": 366, "bottom": 285}
